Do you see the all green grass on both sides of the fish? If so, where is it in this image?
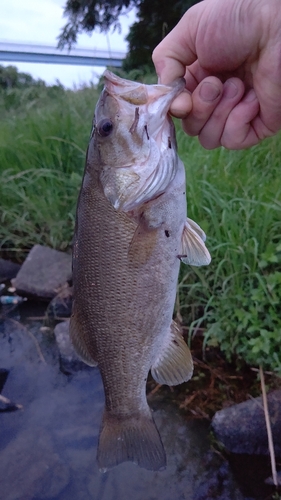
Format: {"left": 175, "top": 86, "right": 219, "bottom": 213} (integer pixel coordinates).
{"left": 0, "top": 81, "right": 281, "bottom": 373}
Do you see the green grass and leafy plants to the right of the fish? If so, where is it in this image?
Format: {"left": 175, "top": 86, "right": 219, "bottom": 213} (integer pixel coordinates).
{"left": 178, "top": 131, "right": 281, "bottom": 373}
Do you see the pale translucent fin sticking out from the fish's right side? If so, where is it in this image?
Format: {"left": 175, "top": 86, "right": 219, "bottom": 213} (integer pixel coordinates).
{"left": 179, "top": 219, "right": 211, "bottom": 266}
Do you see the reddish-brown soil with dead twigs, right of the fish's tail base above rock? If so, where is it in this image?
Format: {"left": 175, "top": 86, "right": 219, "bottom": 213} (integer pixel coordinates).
{"left": 147, "top": 335, "right": 281, "bottom": 420}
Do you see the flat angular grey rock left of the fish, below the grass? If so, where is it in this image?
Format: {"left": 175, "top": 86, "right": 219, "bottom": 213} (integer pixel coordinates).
{"left": 12, "top": 245, "right": 71, "bottom": 300}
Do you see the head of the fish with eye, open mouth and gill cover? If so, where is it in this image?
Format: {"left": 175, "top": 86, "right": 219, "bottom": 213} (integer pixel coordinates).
{"left": 92, "top": 71, "right": 185, "bottom": 211}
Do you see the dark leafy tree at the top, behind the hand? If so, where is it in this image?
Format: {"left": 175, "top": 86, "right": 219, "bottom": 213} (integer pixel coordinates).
{"left": 58, "top": 0, "right": 201, "bottom": 70}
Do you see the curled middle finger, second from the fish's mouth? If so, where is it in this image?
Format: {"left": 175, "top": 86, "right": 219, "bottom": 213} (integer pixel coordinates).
{"left": 179, "top": 76, "right": 223, "bottom": 135}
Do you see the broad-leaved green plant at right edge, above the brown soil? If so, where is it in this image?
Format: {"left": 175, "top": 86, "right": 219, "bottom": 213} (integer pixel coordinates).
{"left": 202, "top": 244, "right": 281, "bottom": 373}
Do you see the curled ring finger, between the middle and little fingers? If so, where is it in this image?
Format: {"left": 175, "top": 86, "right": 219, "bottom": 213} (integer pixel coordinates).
{"left": 199, "top": 78, "right": 245, "bottom": 149}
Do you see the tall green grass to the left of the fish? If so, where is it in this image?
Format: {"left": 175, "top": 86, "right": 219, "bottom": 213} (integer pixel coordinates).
{"left": 0, "top": 88, "right": 98, "bottom": 259}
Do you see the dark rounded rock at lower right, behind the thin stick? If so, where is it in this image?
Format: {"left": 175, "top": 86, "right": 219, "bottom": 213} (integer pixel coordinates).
{"left": 212, "top": 390, "right": 281, "bottom": 457}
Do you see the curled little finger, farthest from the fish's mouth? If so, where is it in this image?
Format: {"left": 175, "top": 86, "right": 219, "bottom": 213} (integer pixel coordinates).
{"left": 221, "top": 89, "right": 260, "bottom": 149}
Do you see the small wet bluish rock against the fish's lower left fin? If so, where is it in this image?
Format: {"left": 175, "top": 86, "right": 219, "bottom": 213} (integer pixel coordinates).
{"left": 54, "top": 320, "right": 89, "bottom": 373}
